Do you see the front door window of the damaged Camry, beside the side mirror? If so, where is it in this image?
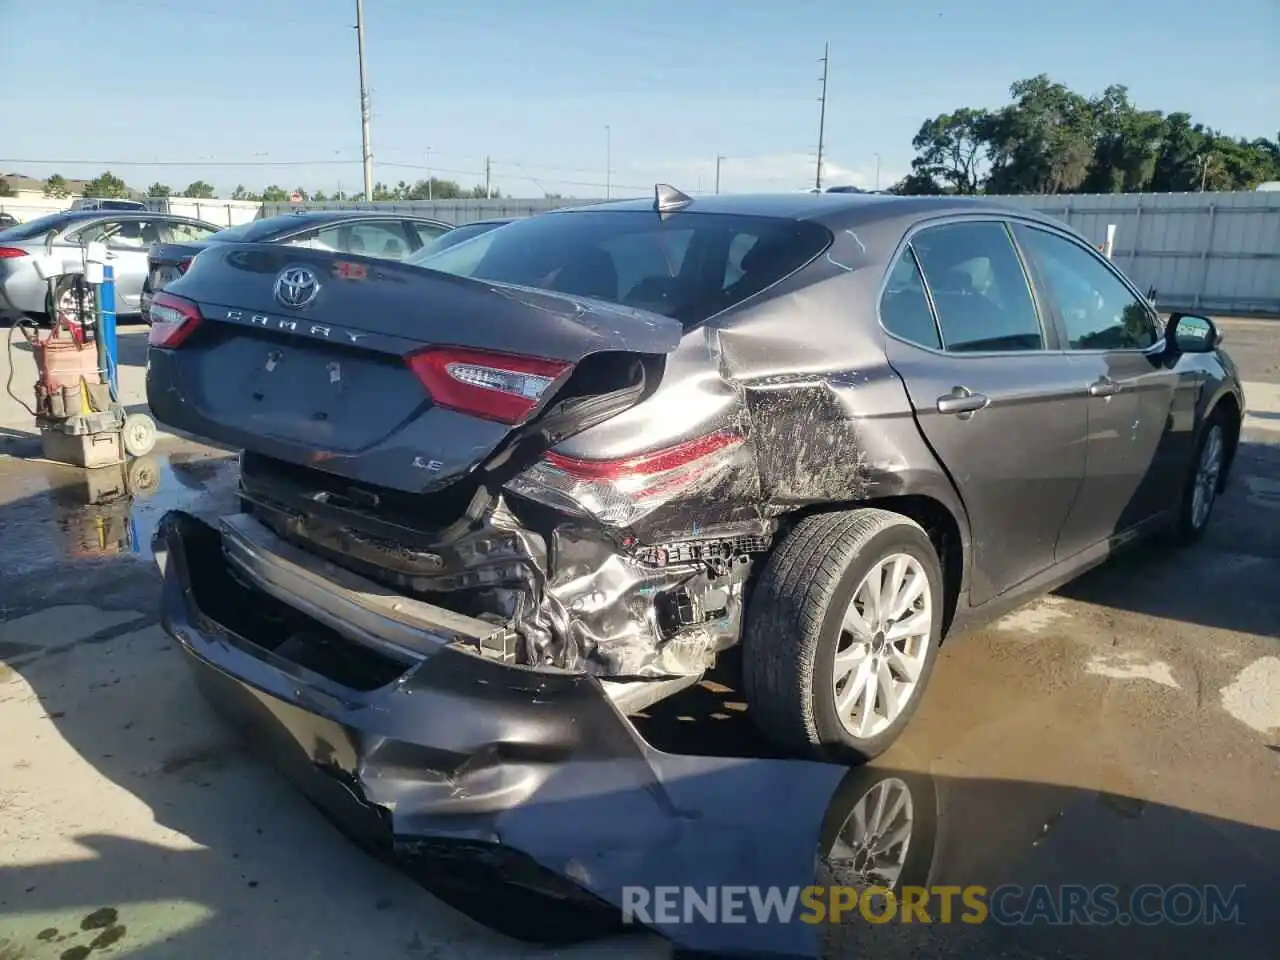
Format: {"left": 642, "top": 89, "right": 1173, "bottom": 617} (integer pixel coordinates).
{"left": 1016, "top": 225, "right": 1158, "bottom": 349}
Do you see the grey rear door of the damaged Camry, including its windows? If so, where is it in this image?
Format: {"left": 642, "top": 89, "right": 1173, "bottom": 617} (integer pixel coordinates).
{"left": 879, "top": 218, "right": 1087, "bottom": 605}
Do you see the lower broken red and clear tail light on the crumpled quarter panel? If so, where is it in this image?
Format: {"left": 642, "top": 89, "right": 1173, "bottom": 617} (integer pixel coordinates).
{"left": 507, "top": 433, "right": 744, "bottom": 526}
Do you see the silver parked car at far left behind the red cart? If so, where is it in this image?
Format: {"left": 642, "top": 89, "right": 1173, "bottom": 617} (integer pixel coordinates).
{"left": 0, "top": 210, "right": 219, "bottom": 319}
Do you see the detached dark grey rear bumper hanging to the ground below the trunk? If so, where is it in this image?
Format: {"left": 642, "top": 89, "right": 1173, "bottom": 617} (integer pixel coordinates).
{"left": 154, "top": 512, "right": 680, "bottom": 846}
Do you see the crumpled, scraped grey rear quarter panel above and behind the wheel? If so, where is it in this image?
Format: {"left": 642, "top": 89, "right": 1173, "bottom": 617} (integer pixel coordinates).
{"left": 522, "top": 216, "right": 968, "bottom": 673}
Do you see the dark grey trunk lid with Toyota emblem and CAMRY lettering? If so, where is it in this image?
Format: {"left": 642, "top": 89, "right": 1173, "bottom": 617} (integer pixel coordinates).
{"left": 147, "top": 243, "right": 682, "bottom": 493}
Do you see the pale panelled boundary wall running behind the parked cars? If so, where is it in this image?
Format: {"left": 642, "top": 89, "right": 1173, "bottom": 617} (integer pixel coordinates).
{"left": 262, "top": 191, "right": 1280, "bottom": 315}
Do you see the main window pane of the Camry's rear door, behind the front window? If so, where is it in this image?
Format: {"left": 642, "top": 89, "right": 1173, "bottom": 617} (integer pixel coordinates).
{"left": 911, "top": 221, "right": 1044, "bottom": 353}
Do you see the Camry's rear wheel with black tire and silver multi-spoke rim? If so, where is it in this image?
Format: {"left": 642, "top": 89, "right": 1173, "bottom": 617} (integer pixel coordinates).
{"left": 742, "top": 508, "right": 945, "bottom": 763}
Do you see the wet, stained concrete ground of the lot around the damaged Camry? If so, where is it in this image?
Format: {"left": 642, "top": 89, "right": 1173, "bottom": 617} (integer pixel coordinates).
{"left": 0, "top": 321, "right": 1280, "bottom": 960}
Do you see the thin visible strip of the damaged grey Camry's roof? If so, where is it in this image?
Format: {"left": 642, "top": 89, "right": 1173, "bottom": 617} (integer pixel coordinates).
{"left": 550, "top": 192, "right": 1056, "bottom": 227}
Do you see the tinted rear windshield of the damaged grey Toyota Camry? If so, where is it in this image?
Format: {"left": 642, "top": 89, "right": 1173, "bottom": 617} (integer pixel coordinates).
{"left": 410, "top": 210, "right": 831, "bottom": 326}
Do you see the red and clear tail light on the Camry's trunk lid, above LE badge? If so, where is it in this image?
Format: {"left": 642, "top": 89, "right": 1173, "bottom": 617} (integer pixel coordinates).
{"left": 406, "top": 347, "right": 572, "bottom": 424}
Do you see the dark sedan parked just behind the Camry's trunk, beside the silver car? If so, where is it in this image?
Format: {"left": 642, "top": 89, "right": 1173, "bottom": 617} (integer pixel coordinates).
{"left": 142, "top": 210, "right": 453, "bottom": 320}
